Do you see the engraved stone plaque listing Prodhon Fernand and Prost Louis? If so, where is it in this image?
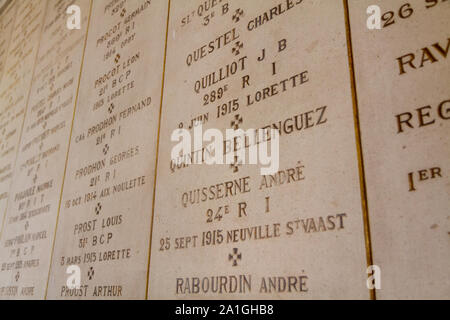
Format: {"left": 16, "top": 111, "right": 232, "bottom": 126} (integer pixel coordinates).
{"left": 48, "top": 0, "right": 168, "bottom": 299}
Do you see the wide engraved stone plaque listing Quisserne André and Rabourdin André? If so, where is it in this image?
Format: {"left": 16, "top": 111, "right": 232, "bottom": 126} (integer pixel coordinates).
{"left": 149, "top": 0, "right": 369, "bottom": 299}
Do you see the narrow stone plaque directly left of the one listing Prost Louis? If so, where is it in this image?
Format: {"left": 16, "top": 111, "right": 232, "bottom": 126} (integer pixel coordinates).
{"left": 0, "top": 0, "right": 90, "bottom": 299}
